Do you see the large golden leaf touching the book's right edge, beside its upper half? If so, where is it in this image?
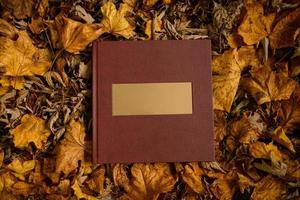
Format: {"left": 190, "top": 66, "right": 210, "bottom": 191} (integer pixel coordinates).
{"left": 212, "top": 46, "right": 258, "bottom": 112}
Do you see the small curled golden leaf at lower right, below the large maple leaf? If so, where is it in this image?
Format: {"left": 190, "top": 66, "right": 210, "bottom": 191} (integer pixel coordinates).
{"left": 249, "top": 142, "right": 282, "bottom": 163}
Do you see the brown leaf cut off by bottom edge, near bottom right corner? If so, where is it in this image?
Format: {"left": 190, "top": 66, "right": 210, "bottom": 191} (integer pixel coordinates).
{"left": 251, "top": 175, "right": 285, "bottom": 200}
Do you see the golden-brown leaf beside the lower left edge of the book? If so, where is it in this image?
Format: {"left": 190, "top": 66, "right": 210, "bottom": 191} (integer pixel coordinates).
{"left": 56, "top": 119, "right": 85, "bottom": 176}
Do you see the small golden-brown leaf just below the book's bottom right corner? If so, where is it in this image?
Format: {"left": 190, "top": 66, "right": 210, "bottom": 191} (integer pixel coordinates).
{"left": 181, "top": 162, "right": 204, "bottom": 193}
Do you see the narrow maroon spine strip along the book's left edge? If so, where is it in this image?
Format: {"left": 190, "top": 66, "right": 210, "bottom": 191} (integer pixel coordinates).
{"left": 92, "top": 42, "right": 98, "bottom": 164}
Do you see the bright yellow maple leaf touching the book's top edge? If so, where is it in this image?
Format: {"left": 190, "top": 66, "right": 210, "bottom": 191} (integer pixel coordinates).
{"left": 101, "top": 1, "right": 135, "bottom": 39}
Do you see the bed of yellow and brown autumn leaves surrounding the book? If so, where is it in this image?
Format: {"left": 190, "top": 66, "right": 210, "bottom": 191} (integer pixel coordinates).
{"left": 0, "top": 0, "right": 300, "bottom": 200}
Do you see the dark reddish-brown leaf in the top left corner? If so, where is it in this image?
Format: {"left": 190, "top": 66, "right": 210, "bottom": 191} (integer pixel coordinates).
{"left": 1, "top": 0, "right": 36, "bottom": 19}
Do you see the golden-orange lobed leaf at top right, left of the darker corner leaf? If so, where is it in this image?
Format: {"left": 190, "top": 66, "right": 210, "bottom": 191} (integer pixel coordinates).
{"left": 238, "top": 3, "right": 275, "bottom": 45}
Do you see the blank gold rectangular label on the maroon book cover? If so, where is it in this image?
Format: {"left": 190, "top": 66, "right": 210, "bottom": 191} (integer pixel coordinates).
{"left": 112, "top": 82, "right": 193, "bottom": 116}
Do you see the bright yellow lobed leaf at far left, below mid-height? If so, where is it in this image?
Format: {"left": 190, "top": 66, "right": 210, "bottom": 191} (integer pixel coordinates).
{"left": 10, "top": 114, "right": 50, "bottom": 149}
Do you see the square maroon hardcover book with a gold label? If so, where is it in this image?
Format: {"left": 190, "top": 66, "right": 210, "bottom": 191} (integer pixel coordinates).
{"left": 93, "top": 40, "right": 214, "bottom": 163}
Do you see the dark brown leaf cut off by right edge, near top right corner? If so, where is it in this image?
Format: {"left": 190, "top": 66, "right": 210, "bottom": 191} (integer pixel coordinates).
{"left": 270, "top": 7, "right": 300, "bottom": 48}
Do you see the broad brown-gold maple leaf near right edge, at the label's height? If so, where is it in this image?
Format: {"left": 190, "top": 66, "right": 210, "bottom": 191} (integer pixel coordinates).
{"left": 241, "top": 62, "right": 297, "bottom": 105}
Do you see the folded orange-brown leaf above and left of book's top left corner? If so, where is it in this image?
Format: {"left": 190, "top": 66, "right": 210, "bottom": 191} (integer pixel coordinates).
{"left": 54, "top": 17, "right": 105, "bottom": 53}
